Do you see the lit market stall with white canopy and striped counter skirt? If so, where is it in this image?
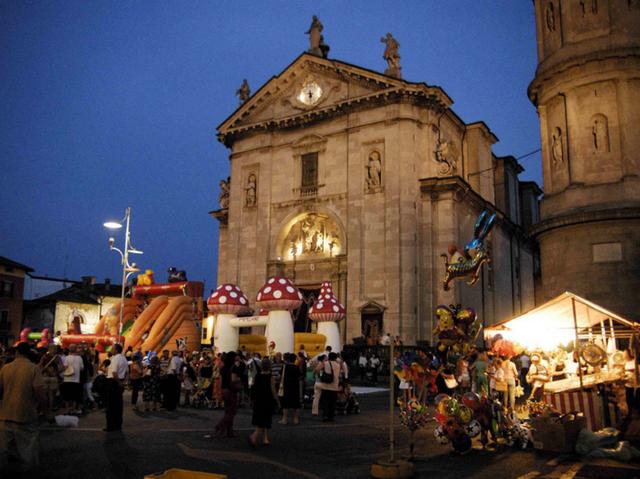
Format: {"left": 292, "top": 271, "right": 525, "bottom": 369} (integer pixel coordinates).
{"left": 484, "top": 292, "right": 640, "bottom": 430}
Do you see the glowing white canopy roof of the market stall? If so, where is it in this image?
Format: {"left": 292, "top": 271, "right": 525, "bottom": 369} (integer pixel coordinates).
{"left": 484, "top": 291, "right": 638, "bottom": 349}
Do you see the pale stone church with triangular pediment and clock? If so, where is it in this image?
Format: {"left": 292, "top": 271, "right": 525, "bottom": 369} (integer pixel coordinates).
{"left": 211, "top": 48, "right": 541, "bottom": 344}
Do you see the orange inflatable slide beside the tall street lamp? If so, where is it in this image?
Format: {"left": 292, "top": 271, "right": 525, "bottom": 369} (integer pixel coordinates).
{"left": 60, "top": 268, "right": 204, "bottom": 352}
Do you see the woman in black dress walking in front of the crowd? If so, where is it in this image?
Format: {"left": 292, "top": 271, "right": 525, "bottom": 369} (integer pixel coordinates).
{"left": 249, "top": 358, "right": 278, "bottom": 447}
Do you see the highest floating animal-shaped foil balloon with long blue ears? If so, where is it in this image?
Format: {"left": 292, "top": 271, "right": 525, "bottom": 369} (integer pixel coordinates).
{"left": 441, "top": 211, "right": 496, "bottom": 291}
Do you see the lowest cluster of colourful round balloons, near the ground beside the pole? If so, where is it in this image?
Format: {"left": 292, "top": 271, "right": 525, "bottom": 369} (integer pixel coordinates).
{"left": 433, "top": 393, "right": 481, "bottom": 453}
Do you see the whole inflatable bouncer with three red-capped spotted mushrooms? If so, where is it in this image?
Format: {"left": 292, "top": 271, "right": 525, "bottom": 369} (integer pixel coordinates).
{"left": 207, "top": 277, "right": 346, "bottom": 355}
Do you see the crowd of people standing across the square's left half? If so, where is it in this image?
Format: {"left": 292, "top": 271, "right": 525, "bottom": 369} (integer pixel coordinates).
{"left": 0, "top": 343, "right": 357, "bottom": 469}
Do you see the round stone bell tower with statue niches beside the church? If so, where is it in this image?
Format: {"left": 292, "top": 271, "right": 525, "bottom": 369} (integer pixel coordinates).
{"left": 529, "top": 0, "right": 640, "bottom": 320}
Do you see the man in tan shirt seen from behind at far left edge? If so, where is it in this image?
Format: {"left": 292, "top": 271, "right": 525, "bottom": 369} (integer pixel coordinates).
{"left": 0, "top": 343, "right": 46, "bottom": 477}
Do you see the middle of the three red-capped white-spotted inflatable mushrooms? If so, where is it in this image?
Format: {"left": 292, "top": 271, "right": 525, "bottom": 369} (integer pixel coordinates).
{"left": 256, "top": 276, "right": 302, "bottom": 353}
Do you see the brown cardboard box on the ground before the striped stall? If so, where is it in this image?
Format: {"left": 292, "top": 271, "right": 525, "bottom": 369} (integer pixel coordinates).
{"left": 531, "top": 416, "right": 587, "bottom": 453}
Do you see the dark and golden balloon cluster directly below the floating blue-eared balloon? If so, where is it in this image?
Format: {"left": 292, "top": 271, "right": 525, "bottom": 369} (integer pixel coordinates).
{"left": 436, "top": 304, "right": 482, "bottom": 354}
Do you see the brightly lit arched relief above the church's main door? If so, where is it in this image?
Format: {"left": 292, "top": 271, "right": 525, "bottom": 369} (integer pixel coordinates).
{"left": 281, "top": 213, "right": 343, "bottom": 261}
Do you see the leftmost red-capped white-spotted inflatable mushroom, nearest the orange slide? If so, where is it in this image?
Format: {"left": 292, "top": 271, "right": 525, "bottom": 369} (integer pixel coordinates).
{"left": 207, "top": 283, "right": 249, "bottom": 353}
